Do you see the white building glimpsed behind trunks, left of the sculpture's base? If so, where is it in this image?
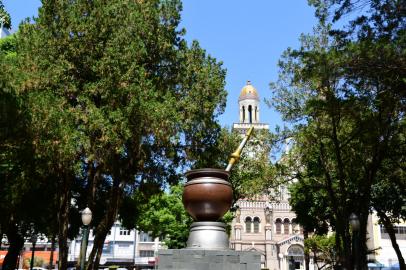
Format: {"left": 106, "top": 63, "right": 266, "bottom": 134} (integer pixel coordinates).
{"left": 68, "top": 221, "right": 162, "bottom": 269}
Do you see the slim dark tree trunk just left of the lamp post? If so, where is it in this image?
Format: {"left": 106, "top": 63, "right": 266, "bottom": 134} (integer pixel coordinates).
{"left": 58, "top": 174, "right": 71, "bottom": 270}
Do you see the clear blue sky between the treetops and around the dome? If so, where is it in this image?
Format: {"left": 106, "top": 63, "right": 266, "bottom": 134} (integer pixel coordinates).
{"left": 3, "top": 0, "right": 317, "bottom": 130}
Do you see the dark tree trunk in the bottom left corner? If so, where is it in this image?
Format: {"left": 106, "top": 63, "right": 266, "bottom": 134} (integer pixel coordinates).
{"left": 2, "top": 221, "right": 24, "bottom": 270}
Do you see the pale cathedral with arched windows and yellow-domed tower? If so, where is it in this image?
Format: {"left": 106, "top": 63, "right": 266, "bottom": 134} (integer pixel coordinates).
{"left": 230, "top": 81, "right": 304, "bottom": 270}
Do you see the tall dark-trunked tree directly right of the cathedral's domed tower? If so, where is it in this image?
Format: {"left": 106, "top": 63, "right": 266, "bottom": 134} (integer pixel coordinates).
{"left": 271, "top": 1, "right": 405, "bottom": 269}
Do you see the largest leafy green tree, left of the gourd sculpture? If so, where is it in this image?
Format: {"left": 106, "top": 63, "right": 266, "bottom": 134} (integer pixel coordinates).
{"left": 17, "top": 0, "right": 226, "bottom": 269}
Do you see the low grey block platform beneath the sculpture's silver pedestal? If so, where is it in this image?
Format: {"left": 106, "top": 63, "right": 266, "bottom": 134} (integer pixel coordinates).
{"left": 158, "top": 249, "right": 261, "bottom": 270}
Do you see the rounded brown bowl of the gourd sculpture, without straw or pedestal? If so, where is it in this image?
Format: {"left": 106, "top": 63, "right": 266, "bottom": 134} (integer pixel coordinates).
{"left": 183, "top": 168, "right": 233, "bottom": 221}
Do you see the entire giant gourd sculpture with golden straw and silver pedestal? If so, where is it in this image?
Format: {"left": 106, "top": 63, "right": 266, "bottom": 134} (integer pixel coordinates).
{"left": 183, "top": 127, "right": 253, "bottom": 249}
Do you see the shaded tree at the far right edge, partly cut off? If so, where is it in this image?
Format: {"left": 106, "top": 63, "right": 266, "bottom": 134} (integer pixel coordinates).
{"left": 309, "top": 0, "right": 406, "bottom": 269}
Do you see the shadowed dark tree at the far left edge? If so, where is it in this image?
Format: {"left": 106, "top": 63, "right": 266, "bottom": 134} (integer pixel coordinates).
{"left": 0, "top": 34, "right": 57, "bottom": 269}
